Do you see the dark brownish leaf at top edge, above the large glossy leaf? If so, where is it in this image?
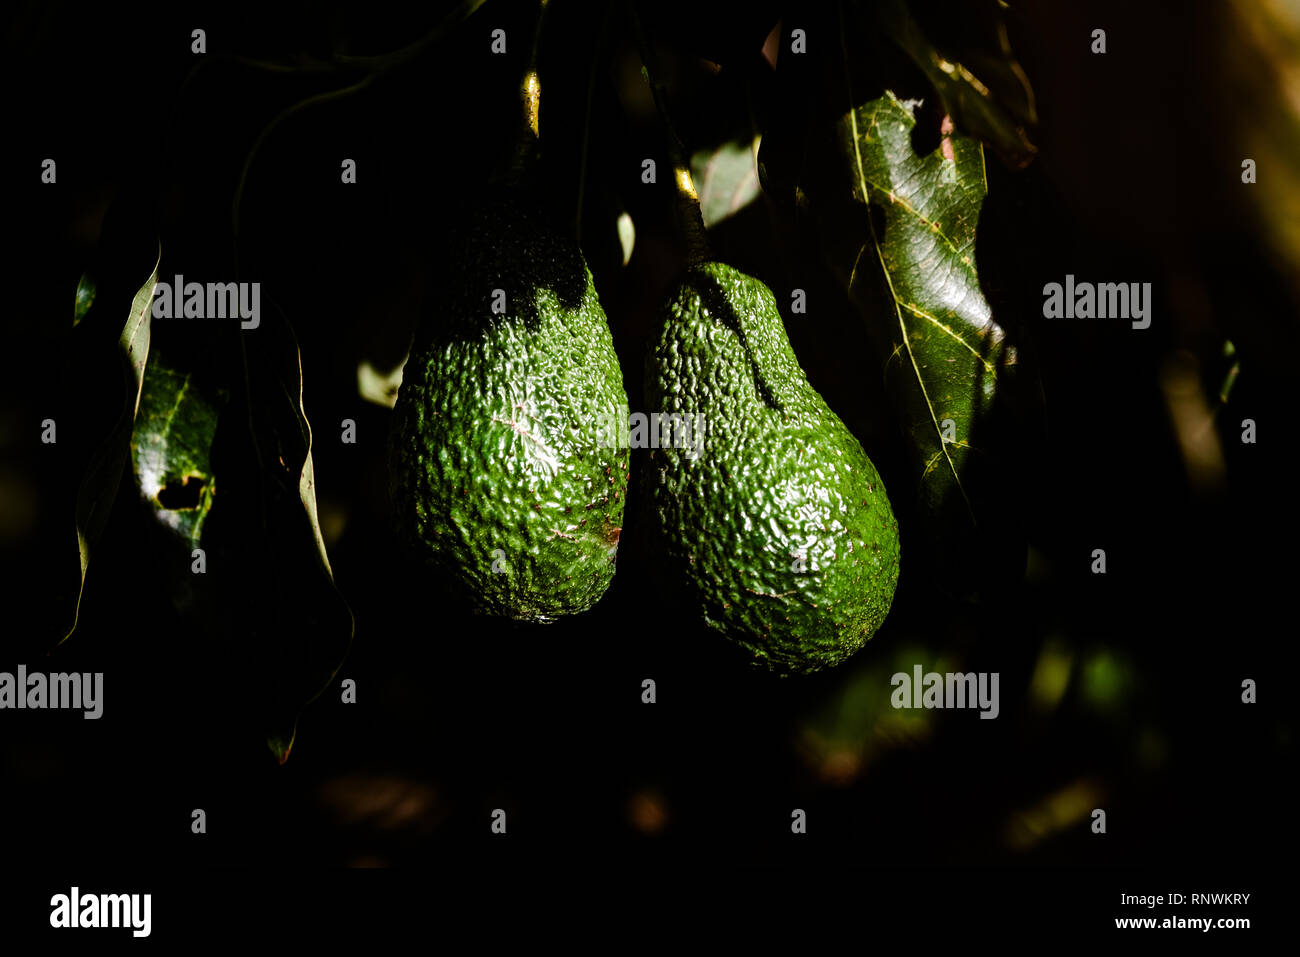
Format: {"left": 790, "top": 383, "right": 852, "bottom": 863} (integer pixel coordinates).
{"left": 872, "top": 0, "right": 1037, "bottom": 168}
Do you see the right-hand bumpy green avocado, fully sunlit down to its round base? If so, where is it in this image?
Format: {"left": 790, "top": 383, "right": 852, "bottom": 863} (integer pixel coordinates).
{"left": 646, "top": 263, "right": 898, "bottom": 675}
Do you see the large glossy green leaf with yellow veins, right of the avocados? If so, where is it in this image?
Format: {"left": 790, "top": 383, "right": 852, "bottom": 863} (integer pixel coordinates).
{"left": 831, "top": 91, "right": 1023, "bottom": 598}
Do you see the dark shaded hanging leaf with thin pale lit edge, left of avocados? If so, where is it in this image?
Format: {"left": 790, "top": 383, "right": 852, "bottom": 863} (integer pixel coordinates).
{"left": 204, "top": 299, "right": 352, "bottom": 763}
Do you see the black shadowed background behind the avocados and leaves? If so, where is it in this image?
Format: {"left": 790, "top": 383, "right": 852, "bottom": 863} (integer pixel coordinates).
{"left": 0, "top": 0, "right": 1297, "bottom": 910}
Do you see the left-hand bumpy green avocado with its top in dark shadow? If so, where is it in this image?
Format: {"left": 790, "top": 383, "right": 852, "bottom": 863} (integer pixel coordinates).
{"left": 389, "top": 190, "right": 628, "bottom": 623}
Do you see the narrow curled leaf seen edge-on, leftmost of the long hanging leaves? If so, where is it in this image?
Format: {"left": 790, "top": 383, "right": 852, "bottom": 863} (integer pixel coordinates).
{"left": 59, "top": 240, "right": 163, "bottom": 642}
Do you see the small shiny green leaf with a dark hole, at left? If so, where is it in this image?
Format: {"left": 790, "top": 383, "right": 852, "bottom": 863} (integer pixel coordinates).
{"left": 131, "top": 350, "right": 217, "bottom": 547}
